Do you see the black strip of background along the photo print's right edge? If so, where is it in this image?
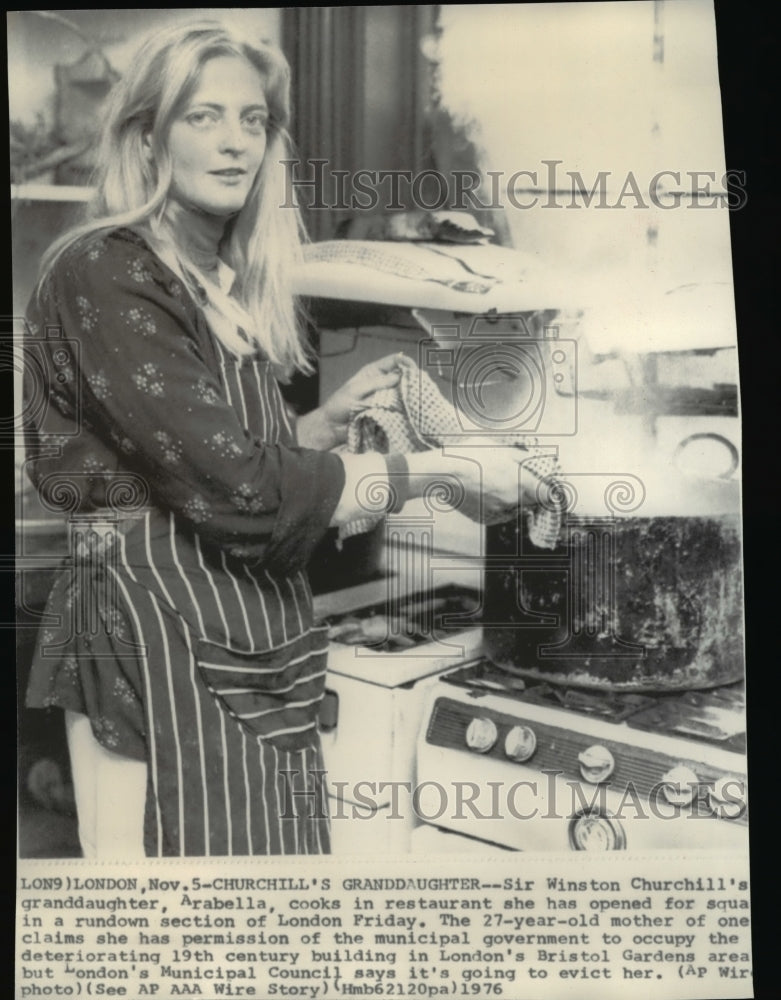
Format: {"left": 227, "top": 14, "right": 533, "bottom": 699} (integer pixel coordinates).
{"left": 715, "top": 0, "right": 779, "bottom": 997}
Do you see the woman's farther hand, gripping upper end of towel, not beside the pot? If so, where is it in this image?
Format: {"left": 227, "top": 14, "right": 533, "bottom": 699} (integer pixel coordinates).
{"left": 297, "top": 354, "right": 401, "bottom": 450}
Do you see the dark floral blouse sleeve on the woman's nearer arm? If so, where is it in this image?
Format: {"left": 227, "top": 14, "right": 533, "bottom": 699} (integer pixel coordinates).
{"left": 42, "top": 237, "right": 344, "bottom": 572}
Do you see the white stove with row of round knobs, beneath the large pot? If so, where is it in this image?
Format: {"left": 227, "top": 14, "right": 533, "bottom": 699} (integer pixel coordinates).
{"left": 412, "top": 658, "right": 747, "bottom": 852}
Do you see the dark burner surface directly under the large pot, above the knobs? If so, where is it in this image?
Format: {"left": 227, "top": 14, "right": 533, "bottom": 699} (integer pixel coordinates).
{"left": 442, "top": 659, "right": 746, "bottom": 752}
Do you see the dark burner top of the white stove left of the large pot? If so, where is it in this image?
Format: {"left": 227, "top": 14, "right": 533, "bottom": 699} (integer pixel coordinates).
{"left": 325, "top": 584, "right": 480, "bottom": 653}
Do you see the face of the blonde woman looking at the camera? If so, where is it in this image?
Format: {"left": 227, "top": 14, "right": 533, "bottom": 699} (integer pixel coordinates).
{"left": 168, "top": 56, "right": 268, "bottom": 216}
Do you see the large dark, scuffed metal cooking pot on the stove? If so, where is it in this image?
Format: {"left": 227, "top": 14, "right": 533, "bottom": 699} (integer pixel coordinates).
{"left": 484, "top": 515, "right": 744, "bottom": 691}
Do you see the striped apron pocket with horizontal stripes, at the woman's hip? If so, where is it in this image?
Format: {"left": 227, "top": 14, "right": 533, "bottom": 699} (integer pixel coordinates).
{"left": 196, "top": 625, "right": 328, "bottom": 750}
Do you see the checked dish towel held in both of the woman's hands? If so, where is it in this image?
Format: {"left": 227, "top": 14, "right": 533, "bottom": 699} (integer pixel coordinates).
{"left": 339, "top": 354, "right": 561, "bottom": 549}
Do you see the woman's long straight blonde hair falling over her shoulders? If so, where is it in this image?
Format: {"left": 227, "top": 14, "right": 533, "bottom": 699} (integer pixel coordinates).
{"left": 39, "top": 20, "right": 311, "bottom": 373}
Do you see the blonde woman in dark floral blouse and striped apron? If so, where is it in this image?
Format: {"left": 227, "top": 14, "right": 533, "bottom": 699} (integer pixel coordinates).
{"left": 22, "top": 22, "right": 536, "bottom": 857}
